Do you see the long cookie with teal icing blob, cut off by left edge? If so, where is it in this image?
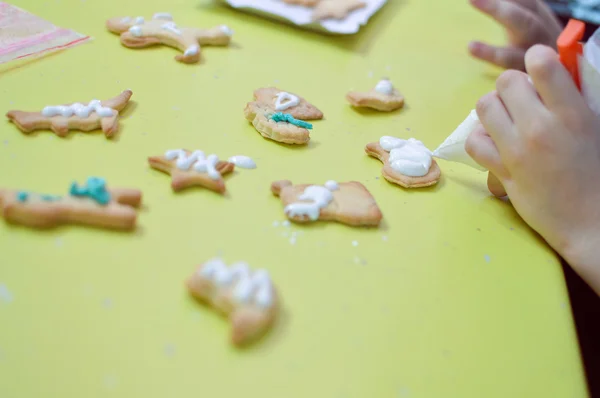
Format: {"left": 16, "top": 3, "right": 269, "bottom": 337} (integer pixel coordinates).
{"left": 0, "top": 177, "right": 142, "bottom": 230}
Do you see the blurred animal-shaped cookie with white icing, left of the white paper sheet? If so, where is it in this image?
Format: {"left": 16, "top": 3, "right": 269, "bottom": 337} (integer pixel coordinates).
{"left": 106, "top": 13, "right": 233, "bottom": 64}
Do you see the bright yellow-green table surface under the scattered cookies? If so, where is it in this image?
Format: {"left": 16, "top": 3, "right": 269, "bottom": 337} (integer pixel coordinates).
{"left": 0, "top": 0, "right": 587, "bottom": 398}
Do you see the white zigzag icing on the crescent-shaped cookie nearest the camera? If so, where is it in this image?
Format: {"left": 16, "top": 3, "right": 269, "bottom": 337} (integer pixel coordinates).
{"left": 200, "top": 259, "right": 273, "bottom": 308}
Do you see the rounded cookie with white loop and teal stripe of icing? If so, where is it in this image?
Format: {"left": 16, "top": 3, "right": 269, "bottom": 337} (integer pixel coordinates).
{"left": 244, "top": 87, "right": 323, "bottom": 145}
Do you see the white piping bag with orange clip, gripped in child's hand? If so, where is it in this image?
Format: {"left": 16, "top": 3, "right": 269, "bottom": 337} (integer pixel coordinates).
{"left": 433, "top": 19, "right": 600, "bottom": 171}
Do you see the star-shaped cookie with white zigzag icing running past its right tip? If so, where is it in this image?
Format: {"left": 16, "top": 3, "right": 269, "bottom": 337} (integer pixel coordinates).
{"left": 148, "top": 149, "right": 241, "bottom": 194}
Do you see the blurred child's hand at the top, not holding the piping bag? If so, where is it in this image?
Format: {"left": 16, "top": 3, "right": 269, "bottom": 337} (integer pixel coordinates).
{"left": 469, "top": 0, "right": 562, "bottom": 70}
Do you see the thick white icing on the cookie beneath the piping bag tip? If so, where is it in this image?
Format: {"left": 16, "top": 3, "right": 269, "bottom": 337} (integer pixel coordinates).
{"left": 379, "top": 136, "right": 432, "bottom": 177}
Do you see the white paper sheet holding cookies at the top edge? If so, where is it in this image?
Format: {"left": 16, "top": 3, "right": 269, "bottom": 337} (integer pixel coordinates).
{"left": 220, "top": 0, "right": 387, "bottom": 35}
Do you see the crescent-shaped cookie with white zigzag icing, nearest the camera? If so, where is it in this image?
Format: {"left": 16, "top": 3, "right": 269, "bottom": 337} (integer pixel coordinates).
{"left": 187, "top": 259, "right": 279, "bottom": 346}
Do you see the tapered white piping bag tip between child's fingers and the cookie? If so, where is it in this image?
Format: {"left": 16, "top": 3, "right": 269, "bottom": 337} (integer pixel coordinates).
{"left": 433, "top": 110, "right": 487, "bottom": 171}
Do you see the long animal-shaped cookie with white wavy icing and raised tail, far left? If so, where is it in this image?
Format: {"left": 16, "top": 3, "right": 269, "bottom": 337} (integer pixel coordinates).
{"left": 6, "top": 90, "right": 133, "bottom": 138}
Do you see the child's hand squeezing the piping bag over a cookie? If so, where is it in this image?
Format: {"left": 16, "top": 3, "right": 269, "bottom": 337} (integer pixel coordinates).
{"left": 466, "top": 46, "right": 600, "bottom": 294}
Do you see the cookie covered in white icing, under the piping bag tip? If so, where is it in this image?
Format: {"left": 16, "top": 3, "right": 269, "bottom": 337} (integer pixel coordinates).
{"left": 365, "top": 136, "right": 442, "bottom": 188}
